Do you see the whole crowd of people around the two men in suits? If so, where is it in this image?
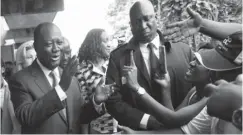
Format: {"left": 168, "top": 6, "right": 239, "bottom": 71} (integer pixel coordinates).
{"left": 0, "top": 0, "right": 243, "bottom": 134}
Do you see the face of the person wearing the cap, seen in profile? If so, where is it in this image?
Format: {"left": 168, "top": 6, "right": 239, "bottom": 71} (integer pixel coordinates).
{"left": 185, "top": 58, "right": 210, "bottom": 83}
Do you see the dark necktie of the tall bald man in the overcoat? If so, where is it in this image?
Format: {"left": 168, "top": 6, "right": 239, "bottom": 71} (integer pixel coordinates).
{"left": 148, "top": 43, "right": 159, "bottom": 80}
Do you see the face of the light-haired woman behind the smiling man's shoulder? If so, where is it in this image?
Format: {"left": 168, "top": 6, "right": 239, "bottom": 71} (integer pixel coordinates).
{"left": 22, "top": 49, "right": 36, "bottom": 68}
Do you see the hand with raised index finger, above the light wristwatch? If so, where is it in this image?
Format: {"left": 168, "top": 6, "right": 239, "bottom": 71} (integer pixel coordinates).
{"left": 123, "top": 50, "right": 140, "bottom": 91}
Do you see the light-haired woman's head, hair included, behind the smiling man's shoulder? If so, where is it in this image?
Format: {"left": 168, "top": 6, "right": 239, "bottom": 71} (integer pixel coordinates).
{"left": 16, "top": 40, "right": 36, "bottom": 72}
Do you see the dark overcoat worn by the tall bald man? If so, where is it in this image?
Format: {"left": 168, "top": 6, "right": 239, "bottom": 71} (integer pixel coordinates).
{"left": 106, "top": 31, "right": 192, "bottom": 129}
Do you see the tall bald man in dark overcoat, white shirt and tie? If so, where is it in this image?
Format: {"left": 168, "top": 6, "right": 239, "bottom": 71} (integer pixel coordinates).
{"left": 106, "top": 1, "right": 193, "bottom": 129}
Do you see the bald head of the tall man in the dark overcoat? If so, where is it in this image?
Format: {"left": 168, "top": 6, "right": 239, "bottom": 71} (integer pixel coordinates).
{"left": 130, "top": 0, "right": 157, "bottom": 43}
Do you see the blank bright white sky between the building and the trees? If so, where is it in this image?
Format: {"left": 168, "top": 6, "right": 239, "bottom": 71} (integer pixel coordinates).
{"left": 53, "top": 0, "right": 113, "bottom": 54}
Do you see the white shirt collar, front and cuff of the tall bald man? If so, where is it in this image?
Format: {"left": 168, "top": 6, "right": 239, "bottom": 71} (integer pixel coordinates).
{"left": 139, "top": 35, "right": 160, "bottom": 129}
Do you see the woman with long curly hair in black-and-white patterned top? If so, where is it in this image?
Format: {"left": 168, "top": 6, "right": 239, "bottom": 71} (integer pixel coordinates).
{"left": 76, "top": 29, "right": 116, "bottom": 134}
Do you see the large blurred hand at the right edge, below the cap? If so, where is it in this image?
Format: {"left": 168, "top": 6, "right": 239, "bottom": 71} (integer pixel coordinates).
{"left": 204, "top": 75, "right": 242, "bottom": 121}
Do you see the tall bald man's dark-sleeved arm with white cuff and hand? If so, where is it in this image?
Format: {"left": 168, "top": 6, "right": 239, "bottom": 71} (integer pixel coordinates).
{"left": 106, "top": 54, "right": 163, "bottom": 129}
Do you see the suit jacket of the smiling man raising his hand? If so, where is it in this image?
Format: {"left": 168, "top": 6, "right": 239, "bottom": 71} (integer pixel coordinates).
{"left": 9, "top": 61, "right": 98, "bottom": 134}
